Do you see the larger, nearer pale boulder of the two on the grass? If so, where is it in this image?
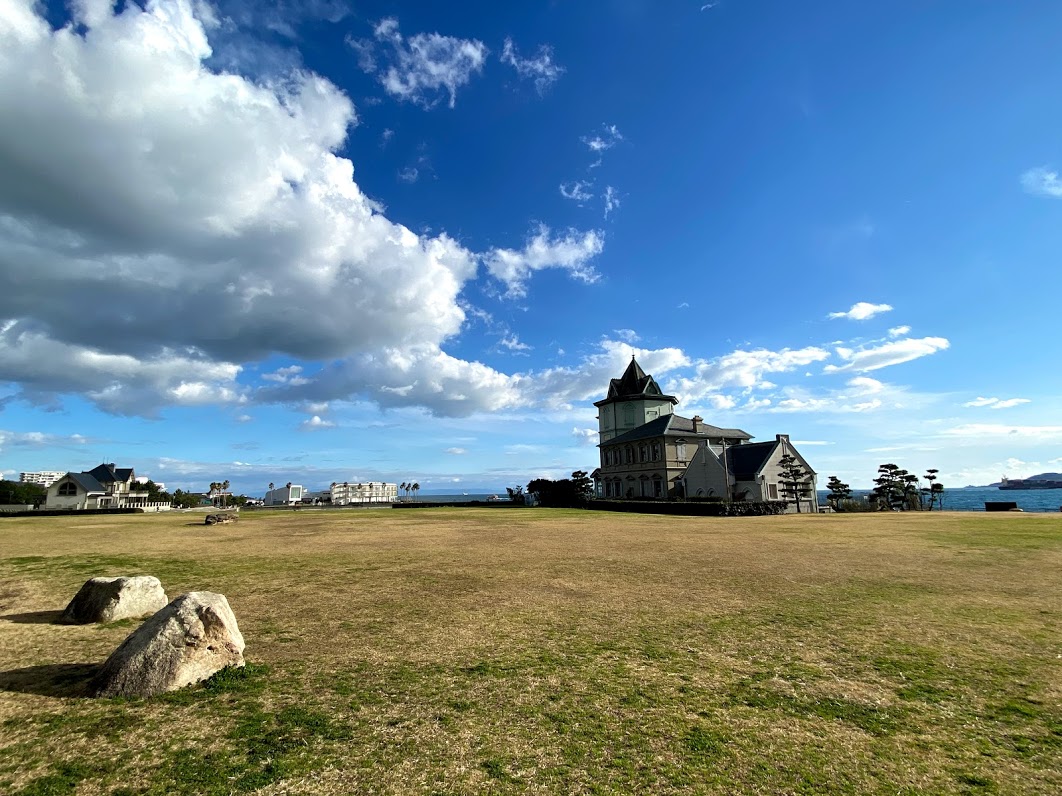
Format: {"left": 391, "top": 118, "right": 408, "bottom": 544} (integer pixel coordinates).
{"left": 93, "top": 591, "right": 243, "bottom": 696}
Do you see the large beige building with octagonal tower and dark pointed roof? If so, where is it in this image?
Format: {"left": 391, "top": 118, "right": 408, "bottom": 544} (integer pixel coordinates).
{"left": 594, "top": 358, "right": 818, "bottom": 512}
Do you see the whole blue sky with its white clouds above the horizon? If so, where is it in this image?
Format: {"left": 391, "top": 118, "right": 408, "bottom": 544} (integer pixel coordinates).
{"left": 0, "top": 0, "right": 1062, "bottom": 495}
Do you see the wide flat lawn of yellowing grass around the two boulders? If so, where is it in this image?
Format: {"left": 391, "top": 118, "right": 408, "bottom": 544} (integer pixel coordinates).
{"left": 0, "top": 508, "right": 1062, "bottom": 796}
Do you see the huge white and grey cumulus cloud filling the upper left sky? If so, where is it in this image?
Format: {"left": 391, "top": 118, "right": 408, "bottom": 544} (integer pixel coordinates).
{"left": 0, "top": 0, "right": 501, "bottom": 414}
